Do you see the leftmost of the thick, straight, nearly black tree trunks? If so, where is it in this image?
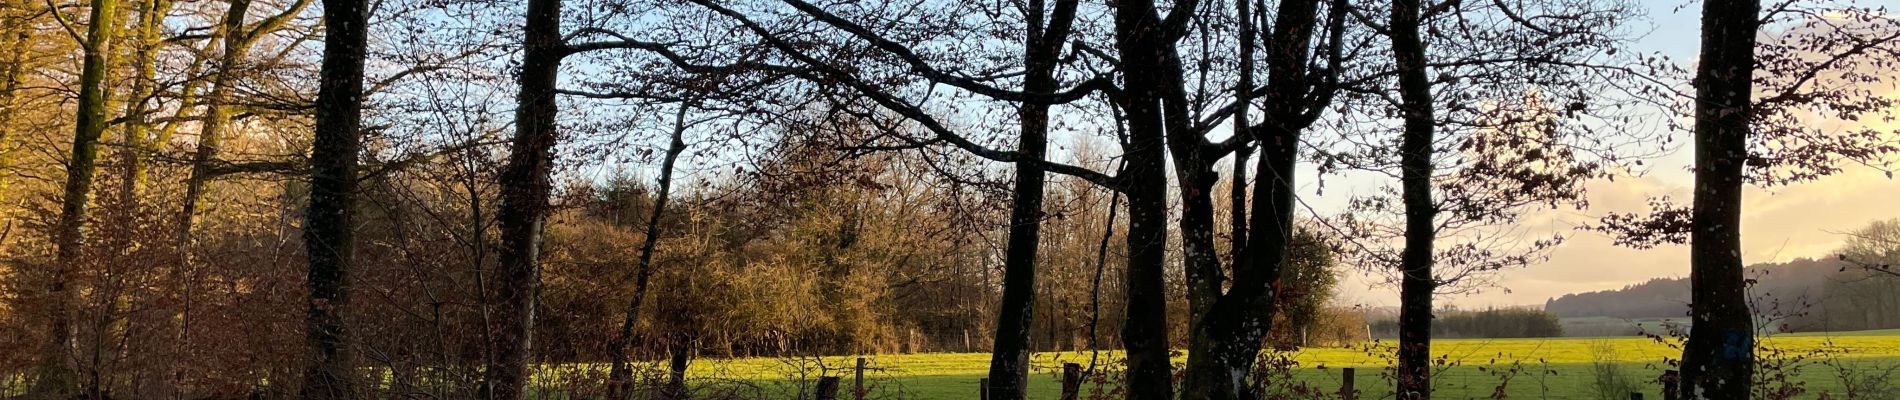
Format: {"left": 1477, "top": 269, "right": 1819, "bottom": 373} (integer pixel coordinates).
{"left": 300, "top": 0, "right": 369, "bottom": 398}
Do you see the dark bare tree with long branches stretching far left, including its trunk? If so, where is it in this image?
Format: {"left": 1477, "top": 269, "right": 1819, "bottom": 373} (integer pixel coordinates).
{"left": 592, "top": 0, "right": 1117, "bottom": 398}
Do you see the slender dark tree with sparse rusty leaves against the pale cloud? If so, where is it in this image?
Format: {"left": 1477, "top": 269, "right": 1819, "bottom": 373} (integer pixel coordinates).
{"left": 1321, "top": 0, "right": 1657, "bottom": 398}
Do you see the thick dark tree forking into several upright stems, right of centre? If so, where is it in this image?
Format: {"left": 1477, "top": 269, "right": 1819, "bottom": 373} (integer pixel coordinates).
{"left": 1169, "top": 0, "right": 1347, "bottom": 398}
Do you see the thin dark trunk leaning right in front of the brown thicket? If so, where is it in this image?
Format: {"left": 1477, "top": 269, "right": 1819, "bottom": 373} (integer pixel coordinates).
{"left": 608, "top": 102, "right": 692, "bottom": 398}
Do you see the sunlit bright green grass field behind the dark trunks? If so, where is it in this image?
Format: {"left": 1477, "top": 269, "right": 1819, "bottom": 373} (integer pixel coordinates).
{"left": 554, "top": 330, "right": 1900, "bottom": 400}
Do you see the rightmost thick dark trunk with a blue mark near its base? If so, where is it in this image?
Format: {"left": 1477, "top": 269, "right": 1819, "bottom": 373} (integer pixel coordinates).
{"left": 1682, "top": 0, "right": 1761, "bottom": 398}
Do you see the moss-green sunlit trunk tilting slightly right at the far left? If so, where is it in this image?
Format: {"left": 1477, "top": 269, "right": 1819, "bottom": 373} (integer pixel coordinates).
{"left": 32, "top": 0, "right": 118, "bottom": 398}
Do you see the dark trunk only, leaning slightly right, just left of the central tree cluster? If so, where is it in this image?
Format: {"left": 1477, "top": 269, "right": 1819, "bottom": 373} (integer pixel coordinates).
{"left": 990, "top": 0, "right": 1075, "bottom": 400}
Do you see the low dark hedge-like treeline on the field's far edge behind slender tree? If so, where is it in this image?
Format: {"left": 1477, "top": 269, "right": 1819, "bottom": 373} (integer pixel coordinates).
{"left": 1372, "top": 307, "right": 1564, "bottom": 339}
